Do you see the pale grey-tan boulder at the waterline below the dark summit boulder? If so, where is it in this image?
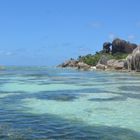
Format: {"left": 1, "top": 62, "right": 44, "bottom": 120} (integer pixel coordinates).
{"left": 107, "top": 59, "right": 127, "bottom": 70}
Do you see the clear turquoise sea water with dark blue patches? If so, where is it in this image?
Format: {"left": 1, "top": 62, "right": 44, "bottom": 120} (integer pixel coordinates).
{"left": 0, "top": 67, "right": 140, "bottom": 140}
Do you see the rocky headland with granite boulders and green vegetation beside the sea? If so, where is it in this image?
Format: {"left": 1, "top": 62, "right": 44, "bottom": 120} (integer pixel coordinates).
{"left": 58, "top": 38, "right": 140, "bottom": 72}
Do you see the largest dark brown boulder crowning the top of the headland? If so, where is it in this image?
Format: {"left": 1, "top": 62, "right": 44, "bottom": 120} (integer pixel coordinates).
{"left": 112, "top": 38, "right": 137, "bottom": 54}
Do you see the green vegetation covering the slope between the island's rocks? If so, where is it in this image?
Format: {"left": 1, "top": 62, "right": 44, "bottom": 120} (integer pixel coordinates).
{"left": 78, "top": 52, "right": 128, "bottom": 66}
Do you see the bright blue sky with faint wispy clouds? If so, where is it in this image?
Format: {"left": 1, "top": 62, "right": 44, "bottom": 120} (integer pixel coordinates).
{"left": 0, "top": 0, "right": 140, "bottom": 66}
